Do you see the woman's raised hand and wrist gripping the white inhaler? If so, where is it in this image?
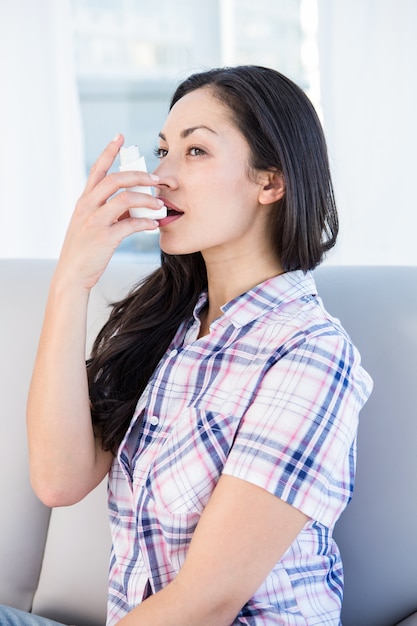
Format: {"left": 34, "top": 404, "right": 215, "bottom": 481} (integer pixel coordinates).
{"left": 57, "top": 135, "right": 163, "bottom": 291}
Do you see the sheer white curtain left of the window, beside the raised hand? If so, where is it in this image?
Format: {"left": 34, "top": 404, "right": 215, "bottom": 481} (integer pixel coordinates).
{"left": 0, "top": 0, "right": 85, "bottom": 258}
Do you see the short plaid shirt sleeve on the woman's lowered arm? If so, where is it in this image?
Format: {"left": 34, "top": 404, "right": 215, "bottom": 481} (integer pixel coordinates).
{"left": 223, "top": 331, "right": 369, "bottom": 528}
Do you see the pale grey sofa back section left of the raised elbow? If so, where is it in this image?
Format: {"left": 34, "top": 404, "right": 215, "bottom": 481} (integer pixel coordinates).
{"left": 0, "top": 261, "right": 50, "bottom": 609}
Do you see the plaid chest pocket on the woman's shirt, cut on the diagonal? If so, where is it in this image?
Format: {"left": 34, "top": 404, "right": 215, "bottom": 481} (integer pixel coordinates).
{"left": 145, "top": 408, "right": 240, "bottom": 514}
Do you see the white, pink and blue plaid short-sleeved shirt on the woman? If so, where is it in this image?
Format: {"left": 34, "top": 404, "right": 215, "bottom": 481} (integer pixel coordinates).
{"left": 108, "top": 271, "right": 372, "bottom": 626}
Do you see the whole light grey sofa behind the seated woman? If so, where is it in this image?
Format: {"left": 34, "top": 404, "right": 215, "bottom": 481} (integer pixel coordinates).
{"left": 0, "top": 260, "right": 417, "bottom": 626}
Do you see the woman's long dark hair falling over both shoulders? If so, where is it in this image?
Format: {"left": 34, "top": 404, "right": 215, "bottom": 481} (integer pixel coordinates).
{"left": 87, "top": 66, "right": 338, "bottom": 452}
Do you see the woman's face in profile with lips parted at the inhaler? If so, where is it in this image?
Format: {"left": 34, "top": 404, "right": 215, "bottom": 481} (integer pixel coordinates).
{"left": 155, "top": 88, "right": 276, "bottom": 262}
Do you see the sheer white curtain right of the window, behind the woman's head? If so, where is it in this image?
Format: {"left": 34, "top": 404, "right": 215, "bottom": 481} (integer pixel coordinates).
{"left": 318, "top": 0, "right": 417, "bottom": 265}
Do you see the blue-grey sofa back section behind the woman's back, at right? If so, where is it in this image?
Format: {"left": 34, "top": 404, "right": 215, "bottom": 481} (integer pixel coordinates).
{"left": 316, "top": 267, "right": 417, "bottom": 626}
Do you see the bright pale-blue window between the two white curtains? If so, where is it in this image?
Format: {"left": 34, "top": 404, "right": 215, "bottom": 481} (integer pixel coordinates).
{"left": 72, "top": 0, "right": 320, "bottom": 256}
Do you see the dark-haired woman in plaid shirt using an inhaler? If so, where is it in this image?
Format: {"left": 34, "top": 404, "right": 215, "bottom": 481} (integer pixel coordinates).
{"left": 2, "top": 66, "right": 371, "bottom": 626}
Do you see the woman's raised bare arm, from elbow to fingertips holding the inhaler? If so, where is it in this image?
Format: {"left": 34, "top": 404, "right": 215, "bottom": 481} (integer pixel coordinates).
{"left": 27, "top": 135, "right": 161, "bottom": 506}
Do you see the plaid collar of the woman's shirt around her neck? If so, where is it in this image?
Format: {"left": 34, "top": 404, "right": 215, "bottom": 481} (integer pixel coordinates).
{"left": 194, "top": 270, "right": 317, "bottom": 328}
